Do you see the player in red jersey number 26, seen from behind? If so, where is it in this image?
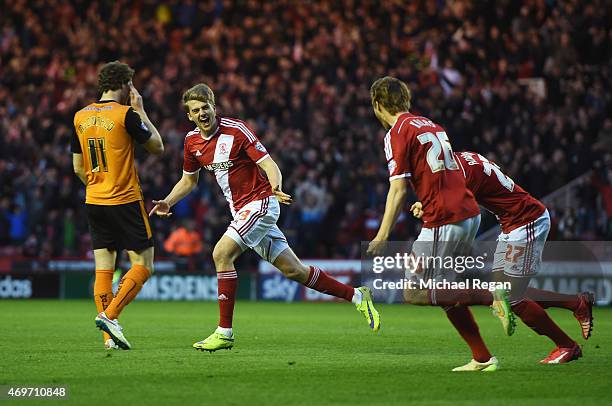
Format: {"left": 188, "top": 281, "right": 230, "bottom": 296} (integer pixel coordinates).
{"left": 368, "top": 76, "right": 498, "bottom": 371}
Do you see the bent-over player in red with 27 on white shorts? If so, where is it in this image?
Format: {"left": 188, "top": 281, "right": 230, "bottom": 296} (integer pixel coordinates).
{"left": 412, "top": 152, "right": 594, "bottom": 364}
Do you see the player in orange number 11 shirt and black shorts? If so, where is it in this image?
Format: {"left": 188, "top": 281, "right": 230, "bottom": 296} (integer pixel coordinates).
{"left": 71, "top": 61, "right": 164, "bottom": 350}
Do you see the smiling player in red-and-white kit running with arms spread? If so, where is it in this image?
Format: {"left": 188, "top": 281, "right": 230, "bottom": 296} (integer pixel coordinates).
{"left": 150, "top": 84, "right": 380, "bottom": 352}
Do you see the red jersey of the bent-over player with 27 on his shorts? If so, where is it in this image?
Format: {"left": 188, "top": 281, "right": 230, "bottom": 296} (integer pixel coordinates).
{"left": 455, "top": 152, "right": 546, "bottom": 234}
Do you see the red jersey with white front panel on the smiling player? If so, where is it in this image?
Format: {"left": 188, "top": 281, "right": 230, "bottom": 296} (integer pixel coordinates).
{"left": 183, "top": 117, "right": 272, "bottom": 215}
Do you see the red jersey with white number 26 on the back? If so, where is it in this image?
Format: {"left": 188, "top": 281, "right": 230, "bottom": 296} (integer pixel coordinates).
{"left": 385, "top": 113, "right": 480, "bottom": 228}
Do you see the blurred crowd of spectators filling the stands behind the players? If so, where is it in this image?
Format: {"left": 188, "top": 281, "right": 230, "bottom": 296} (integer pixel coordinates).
{"left": 0, "top": 0, "right": 612, "bottom": 264}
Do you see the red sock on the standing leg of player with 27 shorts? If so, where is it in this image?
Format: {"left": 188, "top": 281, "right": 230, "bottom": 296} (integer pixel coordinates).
{"left": 512, "top": 298, "right": 575, "bottom": 348}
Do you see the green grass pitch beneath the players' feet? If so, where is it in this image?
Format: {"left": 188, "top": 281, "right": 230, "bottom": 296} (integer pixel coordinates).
{"left": 0, "top": 301, "right": 612, "bottom": 405}
